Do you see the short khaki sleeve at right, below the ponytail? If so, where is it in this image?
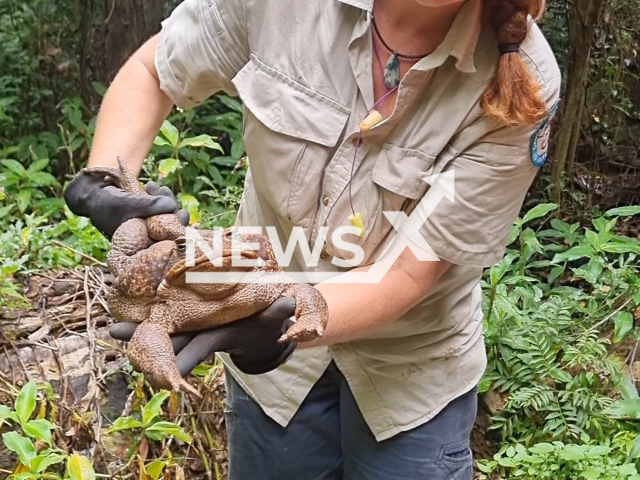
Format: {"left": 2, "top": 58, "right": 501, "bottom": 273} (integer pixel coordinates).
{"left": 420, "top": 77, "right": 560, "bottom": 267}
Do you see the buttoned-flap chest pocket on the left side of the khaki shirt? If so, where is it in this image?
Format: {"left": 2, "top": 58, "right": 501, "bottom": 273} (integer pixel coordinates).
{"left": 233, "top": 55, "right": 350, "bottom": 228}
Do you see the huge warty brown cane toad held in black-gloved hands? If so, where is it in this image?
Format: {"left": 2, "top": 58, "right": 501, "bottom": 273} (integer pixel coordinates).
{"left": 85, "top": 158, "right": 328, "bottom": 395}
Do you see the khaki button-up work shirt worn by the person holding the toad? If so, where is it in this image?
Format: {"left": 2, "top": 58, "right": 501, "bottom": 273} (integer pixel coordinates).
{"left": 156, "top": 0, "right": 560, "bottom": 440}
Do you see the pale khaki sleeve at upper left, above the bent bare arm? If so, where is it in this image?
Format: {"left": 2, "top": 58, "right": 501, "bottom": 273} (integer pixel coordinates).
{"left": 155, "top": 0, "right": 250, "bottom": 110}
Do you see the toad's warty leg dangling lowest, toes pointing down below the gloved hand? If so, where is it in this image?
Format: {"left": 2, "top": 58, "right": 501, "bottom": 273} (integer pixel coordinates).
{"left": 128, "top": 321, "right": 202, "bottom": 398}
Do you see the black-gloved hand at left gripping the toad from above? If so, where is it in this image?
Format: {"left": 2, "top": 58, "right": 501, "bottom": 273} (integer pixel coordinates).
{"left": 64, "top": 168, "right": 189, "bottom": 239}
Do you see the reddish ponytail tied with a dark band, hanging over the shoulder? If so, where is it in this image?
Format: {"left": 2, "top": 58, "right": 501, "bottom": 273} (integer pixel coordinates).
{"left": 481, "top": 0, "right": 547, "bottom": 125}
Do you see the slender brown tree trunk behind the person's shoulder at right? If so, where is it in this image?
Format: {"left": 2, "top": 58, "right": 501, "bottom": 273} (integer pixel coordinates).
{"left": 553, "top": 0, "right": 602, "bottom": 203}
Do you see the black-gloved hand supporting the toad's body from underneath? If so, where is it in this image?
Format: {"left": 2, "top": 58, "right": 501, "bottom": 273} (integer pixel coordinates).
{"left": 109, "top": 297, "right": 297, "bottom": 376}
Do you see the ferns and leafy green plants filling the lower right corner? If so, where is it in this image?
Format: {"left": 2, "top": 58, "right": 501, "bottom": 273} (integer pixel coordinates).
{"left": 481, "top": 204, "right": 640, "bottom": 472}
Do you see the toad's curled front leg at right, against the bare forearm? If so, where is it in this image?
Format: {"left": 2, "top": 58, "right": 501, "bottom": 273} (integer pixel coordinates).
{"left": 279, "top": 283, "right": 329, "bottom": 343}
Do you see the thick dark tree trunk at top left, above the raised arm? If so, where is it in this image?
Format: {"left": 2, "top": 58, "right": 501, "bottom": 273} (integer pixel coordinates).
{"left": 97, "top": 0, "right": 164, "bottom": 84}
